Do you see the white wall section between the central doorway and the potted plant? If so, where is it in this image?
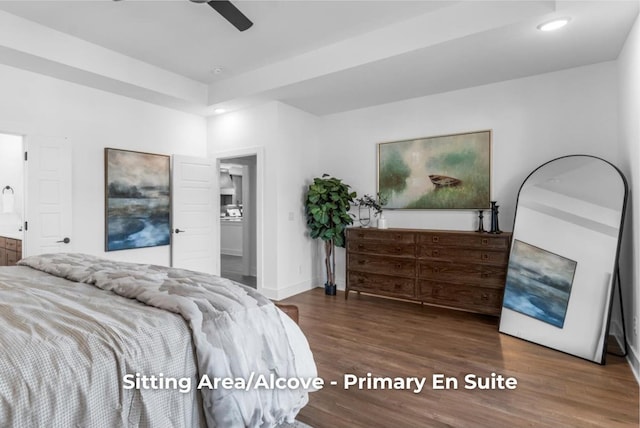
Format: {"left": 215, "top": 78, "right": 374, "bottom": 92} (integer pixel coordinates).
{"left": 208, "top": 102, "right": 318, "bottom": 299}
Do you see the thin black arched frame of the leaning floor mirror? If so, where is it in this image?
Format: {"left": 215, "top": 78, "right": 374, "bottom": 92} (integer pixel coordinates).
{"left": 499, "top": 154, "right": 629, "bottom": 364}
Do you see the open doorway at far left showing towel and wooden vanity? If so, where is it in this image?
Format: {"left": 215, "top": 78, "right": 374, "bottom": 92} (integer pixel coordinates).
{"left": 0, "top": 134, "right": 25, "bottom": 266}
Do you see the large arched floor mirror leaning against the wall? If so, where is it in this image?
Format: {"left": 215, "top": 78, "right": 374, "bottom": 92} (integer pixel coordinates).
{"left": 500, "top": 155, "right": 627, "bottom": 364}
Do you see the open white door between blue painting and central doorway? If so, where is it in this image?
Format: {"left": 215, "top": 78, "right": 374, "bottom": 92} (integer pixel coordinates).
{"left": 171, "top": 155, "right": 220, "bottom": 275}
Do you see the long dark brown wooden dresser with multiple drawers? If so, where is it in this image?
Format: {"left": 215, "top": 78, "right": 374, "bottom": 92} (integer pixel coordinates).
{"left": 345, "top": 228, "right": 511, "bottom": 315}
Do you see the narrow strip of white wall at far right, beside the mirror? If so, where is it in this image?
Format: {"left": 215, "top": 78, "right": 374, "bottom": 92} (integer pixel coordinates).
{"left": 614, "top": 13, "right": 640, "bottom": 381}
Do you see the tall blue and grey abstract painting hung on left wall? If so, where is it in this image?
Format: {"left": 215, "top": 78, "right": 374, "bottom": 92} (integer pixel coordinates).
{"left": 104, "top": 148, "right": 171, "bottom": 251}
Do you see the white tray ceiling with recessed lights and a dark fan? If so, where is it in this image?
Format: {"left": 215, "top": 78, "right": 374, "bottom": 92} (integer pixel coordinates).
{"left": 0, "top": 0, "right": 639, "bottom": 115}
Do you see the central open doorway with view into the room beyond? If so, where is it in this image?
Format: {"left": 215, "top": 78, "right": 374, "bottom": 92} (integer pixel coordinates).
{"left": 220, "top": 155, "right": 258, "bottom": 288}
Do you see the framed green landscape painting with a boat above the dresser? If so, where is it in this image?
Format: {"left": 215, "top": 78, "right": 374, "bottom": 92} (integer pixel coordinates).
{"left": 377, "top": 130, "right": 492, "bottom": 210}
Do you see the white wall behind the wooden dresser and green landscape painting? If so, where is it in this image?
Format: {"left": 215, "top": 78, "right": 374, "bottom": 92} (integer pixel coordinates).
{"left": 319, "top": 62, "right": 620, "bottom": 287}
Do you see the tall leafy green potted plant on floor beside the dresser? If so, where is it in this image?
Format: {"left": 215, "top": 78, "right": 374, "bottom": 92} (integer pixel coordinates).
{"left": 305, "top": 174, "right": 356, "bottom": 295}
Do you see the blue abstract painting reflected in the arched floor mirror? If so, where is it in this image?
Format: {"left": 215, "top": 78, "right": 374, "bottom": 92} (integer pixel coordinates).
{"left": 503, "top": 239, "right": 577, "bottom": 328}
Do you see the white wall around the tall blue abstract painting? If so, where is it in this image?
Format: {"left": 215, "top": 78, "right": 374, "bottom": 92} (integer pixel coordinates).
{"left": 0, "top": 66, "right": 206, "bottom": 265}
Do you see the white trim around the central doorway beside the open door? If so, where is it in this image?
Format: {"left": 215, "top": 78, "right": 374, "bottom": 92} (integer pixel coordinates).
{"left": 212, "top": 146, "right": 264, "bottom": 293}
